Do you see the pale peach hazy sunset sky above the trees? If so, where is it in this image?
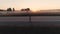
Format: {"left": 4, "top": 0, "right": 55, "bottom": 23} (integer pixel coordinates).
{"left": 0, "top": 0, "right": 60, "bottom": 10}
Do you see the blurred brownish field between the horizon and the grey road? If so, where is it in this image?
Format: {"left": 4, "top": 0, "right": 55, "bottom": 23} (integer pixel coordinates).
{"left": 0, "top": 11, "right": 60, "bottom": 16}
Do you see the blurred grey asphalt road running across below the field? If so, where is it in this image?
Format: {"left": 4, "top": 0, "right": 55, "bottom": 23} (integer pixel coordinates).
{"left": 0, "top": 16, "right": 60, "bottom": 26}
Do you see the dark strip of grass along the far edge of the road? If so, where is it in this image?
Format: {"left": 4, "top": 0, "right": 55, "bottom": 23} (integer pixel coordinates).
{"left": 0, "top": 13, "right": 60, "bottom": 16}
